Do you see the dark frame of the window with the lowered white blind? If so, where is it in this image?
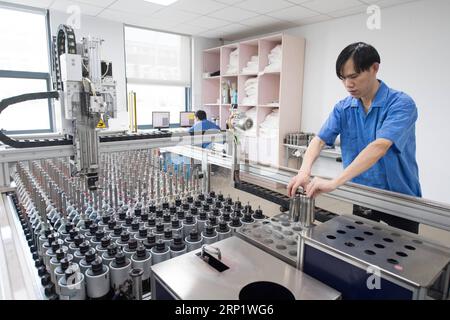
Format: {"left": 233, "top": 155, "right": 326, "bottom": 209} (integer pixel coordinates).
{"left": 123, "top": 23, "right": 193, "bottom": 130}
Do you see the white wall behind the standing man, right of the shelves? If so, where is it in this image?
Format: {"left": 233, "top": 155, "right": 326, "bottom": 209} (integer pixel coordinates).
{"left": 286, "top": 0, "right": 450, "bottom": 203}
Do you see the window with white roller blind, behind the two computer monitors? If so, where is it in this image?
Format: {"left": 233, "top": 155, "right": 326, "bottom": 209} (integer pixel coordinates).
{"left": 125, "top": 26, "right": 191, "bottom": 129}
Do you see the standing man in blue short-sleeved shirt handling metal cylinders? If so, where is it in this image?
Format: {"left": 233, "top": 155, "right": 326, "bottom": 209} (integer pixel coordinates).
{"left": 288, "top": 42, "right": 422, "bottom": 233}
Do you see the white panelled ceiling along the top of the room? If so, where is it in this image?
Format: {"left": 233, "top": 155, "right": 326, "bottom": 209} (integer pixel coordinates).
{"left": 2, "top": 0, "right": 417, "bottom": 40}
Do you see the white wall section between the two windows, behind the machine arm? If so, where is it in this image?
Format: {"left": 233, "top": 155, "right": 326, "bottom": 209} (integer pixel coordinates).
{"left": 50, "top": 10, "right": 128, "bottom": 130}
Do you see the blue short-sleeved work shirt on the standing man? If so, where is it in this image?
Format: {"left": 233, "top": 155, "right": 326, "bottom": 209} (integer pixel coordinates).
{"left": 318, "top": 81, "right": 422, "bottom": 197}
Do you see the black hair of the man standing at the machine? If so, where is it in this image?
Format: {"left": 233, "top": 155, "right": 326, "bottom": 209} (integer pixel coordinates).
{"left": 336, "top": 42, "right": 381, "bottom": 80}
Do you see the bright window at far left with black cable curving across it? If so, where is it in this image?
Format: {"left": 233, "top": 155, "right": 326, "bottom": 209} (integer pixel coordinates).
{"left": 0, "top": 6, "right": 53, "bottom": 134}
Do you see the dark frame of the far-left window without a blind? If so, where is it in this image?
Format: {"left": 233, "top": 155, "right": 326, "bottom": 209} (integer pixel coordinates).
{"left": 0, "top": 2, "right": 56, "bottom": 135}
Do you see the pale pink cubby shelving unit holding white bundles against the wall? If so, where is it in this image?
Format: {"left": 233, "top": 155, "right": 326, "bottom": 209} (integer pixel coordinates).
{"left": 201, "top": 34, "right": 305, "bottom": 166}
